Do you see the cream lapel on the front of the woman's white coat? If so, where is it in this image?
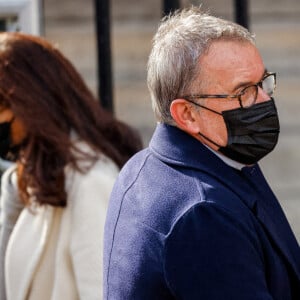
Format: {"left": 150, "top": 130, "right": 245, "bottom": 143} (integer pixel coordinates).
{"left": 5, "top": 205, "right": 53, "bottom": 300}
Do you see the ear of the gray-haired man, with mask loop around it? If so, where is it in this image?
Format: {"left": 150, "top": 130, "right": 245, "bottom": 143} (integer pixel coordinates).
{"left": 170, "top": 99, "right": 200, "bottom": 135}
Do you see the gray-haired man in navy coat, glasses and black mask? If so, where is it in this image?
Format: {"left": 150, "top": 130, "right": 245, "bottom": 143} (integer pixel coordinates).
{"left": 104, "top": 8, "right": 300, "bottom": 300}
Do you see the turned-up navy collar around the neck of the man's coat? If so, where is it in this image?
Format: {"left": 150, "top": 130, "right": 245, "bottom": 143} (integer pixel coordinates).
{"left": 149, "top": 124, "right": 257, "bottom": 210}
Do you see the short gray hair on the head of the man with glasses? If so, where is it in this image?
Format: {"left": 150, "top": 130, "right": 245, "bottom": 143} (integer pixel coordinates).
{"left": 147, "top": 6, "right": 255, "bottom": 124}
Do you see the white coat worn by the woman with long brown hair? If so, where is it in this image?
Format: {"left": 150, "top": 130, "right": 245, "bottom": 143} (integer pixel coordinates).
{"left": 5, "top": 142, "right": 119, "bottom": 300}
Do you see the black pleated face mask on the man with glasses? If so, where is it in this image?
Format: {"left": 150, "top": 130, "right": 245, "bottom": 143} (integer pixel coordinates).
{"left": 199, "top": 98, "right": 280, "bottom": 165}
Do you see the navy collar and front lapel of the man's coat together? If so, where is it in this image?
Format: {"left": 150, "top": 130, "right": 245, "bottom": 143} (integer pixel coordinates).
{"left": 149, "top": 124, "right": 300, "bottom": 281}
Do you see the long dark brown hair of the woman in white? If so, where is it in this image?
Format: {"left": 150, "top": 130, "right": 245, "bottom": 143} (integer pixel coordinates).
{"left": 0, "top": 32, "right": 142, "bottom": 206}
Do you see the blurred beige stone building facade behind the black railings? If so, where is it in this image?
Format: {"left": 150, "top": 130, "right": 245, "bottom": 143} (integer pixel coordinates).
{"left": 44, "top": 0, "right": 300, "bottom": 241}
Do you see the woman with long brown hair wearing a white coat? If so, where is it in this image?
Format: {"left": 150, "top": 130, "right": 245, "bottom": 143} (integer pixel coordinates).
{"left": 0, "top": 33, "right": 141, "bottom": 300}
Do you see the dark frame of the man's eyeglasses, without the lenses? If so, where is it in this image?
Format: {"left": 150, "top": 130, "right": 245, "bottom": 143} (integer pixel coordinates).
{"left": 180, "top": 72, "right": 276, "bottom": 108}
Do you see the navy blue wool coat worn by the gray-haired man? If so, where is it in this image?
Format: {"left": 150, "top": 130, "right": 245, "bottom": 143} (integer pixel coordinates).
{"left": 104, "top": 125, "right": 300, "bottom": 300}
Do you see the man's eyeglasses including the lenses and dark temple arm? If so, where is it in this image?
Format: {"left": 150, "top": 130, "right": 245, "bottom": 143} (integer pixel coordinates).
{"left": 182, "top": 72, "right": 276, "bottom": 107}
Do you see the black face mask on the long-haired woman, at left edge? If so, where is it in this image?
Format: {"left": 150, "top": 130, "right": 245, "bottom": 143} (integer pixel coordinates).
{"left": 0, "top": 118, "right": 20, "bottom": 161}
